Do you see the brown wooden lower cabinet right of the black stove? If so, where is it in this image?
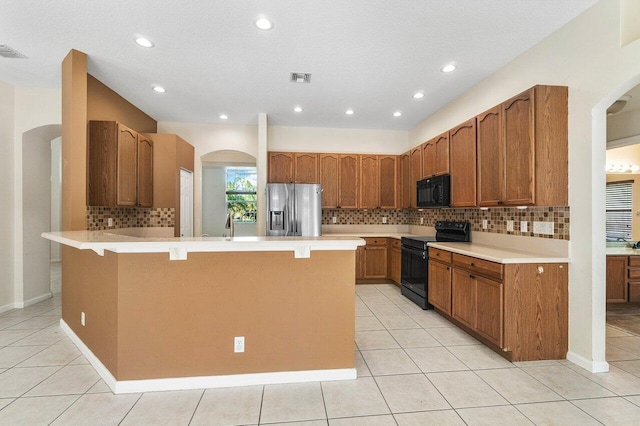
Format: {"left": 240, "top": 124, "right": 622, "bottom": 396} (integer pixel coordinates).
{"left": 429, "top": 248, "right": 564, "bottom": 361}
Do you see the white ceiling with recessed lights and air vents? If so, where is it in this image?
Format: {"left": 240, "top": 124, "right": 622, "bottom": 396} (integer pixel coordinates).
{"left": 0, "top": 0, "right": 597, "bottom": 130}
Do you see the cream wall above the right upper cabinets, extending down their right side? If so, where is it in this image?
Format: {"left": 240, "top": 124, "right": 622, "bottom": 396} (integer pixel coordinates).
{"left": 409, "top": 0, "right": 640, "bottom": 370}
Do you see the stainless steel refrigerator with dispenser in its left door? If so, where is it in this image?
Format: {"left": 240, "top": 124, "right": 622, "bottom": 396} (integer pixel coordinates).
{"left": 267, "top": 183, "right": 322, "bottom": 237}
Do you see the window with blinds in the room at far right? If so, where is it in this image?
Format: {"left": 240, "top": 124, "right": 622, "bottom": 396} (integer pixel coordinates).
{"left": 607, "top": 180, "right": 633, "bottom": 241}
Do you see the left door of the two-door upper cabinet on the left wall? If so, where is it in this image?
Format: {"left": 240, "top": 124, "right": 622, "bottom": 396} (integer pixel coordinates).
{"left": 116, "top": 124, "right": 138, "bottom": 206}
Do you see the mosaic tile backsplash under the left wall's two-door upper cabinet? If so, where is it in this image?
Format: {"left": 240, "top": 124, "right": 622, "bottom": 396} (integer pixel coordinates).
{"left": 87, "top": 207, "right": 176, "bottom": 231}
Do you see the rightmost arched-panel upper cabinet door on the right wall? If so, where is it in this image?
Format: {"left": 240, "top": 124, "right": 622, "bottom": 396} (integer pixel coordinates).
{"left": 502, "top": 89, "right": 535, "bottom": 205}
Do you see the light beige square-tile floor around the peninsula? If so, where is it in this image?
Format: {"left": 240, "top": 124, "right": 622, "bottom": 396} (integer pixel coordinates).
{"left": 0, "top": 284, "right": 640, "bottom": 426}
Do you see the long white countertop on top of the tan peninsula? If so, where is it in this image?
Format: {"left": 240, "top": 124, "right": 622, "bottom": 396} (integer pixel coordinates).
{"left": 42, "top": 231, "right": 365, "bottom": 260}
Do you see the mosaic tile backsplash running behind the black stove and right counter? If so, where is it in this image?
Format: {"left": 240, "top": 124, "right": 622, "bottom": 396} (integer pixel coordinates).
{"left": 322, "top": 206, "right": 570, "bottom": 240}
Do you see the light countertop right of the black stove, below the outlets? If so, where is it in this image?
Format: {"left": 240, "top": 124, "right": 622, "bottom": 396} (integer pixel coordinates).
{"left": 428, "top": 242, "right": 570, "bottom": 263}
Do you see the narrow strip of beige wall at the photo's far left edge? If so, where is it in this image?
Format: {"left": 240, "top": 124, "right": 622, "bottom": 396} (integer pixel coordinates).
{"left": 0, "top": 81, "right": 15, "bottom": 312}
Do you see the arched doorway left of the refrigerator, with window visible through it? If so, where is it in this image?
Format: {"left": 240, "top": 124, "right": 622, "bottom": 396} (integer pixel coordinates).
{"left": 201, "top": 150, "right": 257, "bottom": 237}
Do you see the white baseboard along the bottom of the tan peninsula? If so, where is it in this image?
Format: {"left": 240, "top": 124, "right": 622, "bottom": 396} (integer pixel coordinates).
{"left": 60, "top": 319, "right": 357, "bottom": 394}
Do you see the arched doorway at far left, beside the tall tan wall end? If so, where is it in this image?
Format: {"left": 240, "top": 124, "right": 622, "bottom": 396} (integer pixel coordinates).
{"left": 16, "top": 124, "right": 62, "bottom": 307}
